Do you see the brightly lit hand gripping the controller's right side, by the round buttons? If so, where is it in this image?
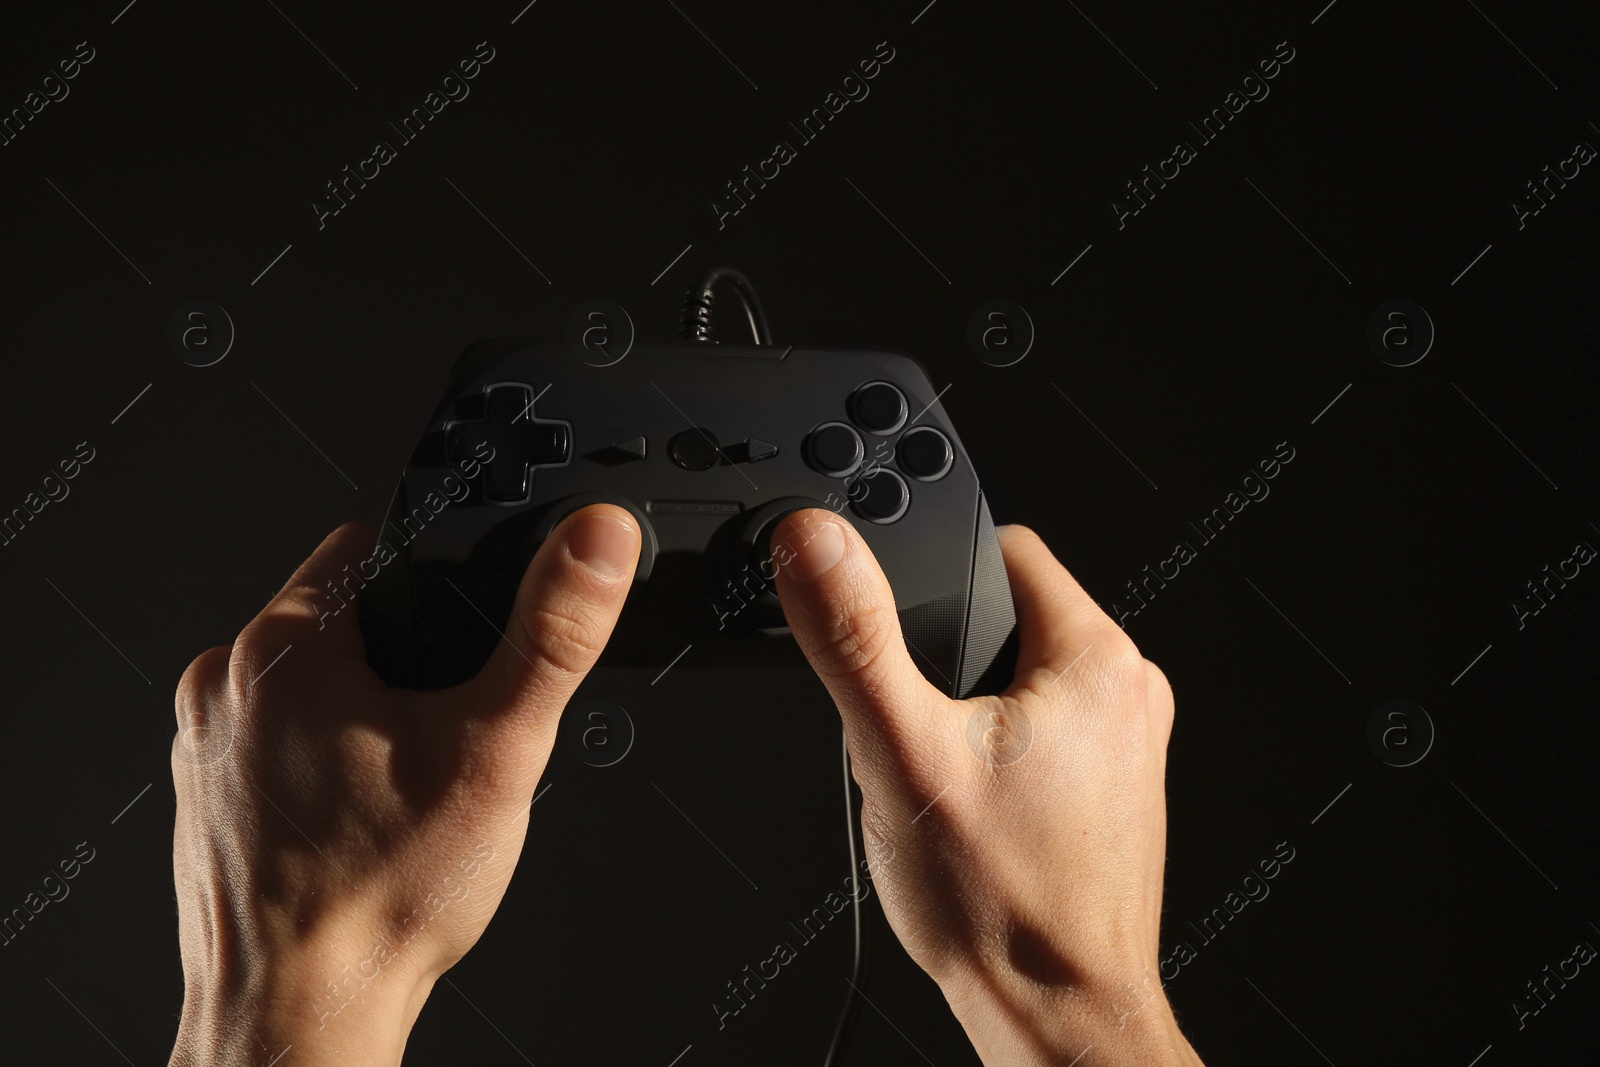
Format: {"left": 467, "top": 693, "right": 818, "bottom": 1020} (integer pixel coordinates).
{"left": 773, "top": 509, "right": 1200, "bottom": 1067}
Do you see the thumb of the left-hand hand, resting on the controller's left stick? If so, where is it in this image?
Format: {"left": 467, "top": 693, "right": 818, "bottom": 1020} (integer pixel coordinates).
{"left": 445, "top": 504, "right": 640, "bottom": 764}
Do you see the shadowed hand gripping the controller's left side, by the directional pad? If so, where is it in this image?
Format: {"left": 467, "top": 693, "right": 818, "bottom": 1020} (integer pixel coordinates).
{"left": 162, "top": 506, "right": 640, "bottom": 1067}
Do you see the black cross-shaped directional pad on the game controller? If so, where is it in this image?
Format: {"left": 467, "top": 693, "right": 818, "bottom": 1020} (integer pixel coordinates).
{"left": 445, "top": 382, "right": 573, "bottom": 504}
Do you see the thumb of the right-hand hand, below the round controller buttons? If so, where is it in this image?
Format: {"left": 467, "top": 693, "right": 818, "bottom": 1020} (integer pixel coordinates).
{"left": 773, "top": 509, "right": 947, "bottom": 763}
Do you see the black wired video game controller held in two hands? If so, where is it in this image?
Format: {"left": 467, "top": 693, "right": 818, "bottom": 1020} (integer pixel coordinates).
{"left": 362, "top": 339, "right": 1014, "bottom": 697}
